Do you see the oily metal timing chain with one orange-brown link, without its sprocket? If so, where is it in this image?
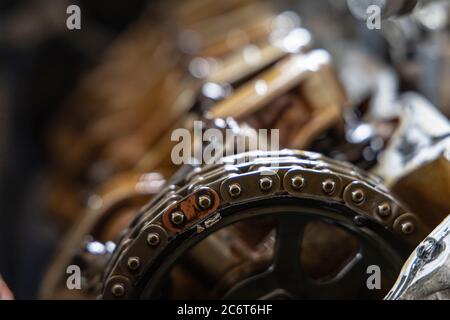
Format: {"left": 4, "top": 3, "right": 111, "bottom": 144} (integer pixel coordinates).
{"left": 101, "top": 150, "right": 426, "bottom": 299}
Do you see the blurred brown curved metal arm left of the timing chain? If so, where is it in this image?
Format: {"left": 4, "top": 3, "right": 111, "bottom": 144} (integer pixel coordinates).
{"left": 39, "top": 173, "right": 165, "bottom": 299}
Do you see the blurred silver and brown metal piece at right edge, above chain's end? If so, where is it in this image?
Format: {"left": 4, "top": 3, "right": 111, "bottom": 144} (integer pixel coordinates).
{"left": 374, "top": 93, "right": 450, "bottom": 232}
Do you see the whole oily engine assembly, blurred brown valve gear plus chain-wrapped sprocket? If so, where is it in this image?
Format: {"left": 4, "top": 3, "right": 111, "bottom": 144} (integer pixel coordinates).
{"left": 28, "top": 0, "right": 450, "bottom": 299}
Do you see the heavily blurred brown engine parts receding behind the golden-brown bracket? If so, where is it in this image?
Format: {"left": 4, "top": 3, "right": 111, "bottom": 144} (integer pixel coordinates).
{"left": 45, "top": 5, "right": 311, "bottom": 224}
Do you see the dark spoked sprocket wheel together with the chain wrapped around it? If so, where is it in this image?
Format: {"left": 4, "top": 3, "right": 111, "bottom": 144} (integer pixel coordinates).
{"left": 102, "top": 150, "right": 424, "bottom": 299}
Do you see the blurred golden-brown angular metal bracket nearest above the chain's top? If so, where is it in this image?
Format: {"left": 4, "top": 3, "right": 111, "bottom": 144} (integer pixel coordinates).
{"left": 135, "top": 50, "right": 346, "bottom": 173}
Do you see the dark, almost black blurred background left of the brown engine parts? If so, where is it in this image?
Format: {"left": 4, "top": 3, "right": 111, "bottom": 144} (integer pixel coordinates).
{"left": 0, "top": 0, "right": 148, "bottom": 298}
